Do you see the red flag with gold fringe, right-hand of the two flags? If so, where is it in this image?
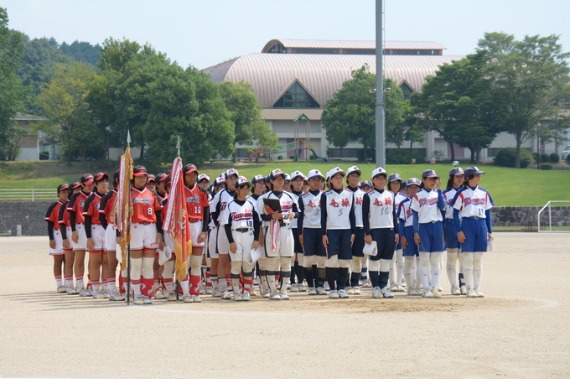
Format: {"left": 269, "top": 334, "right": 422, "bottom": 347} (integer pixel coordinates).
{"left": 163, "top": 158, "right": 192, "bottom": 281}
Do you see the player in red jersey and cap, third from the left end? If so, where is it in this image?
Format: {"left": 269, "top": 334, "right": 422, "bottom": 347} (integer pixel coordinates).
{"left": 67, "top": 174, "right": 94, "bottom": 296}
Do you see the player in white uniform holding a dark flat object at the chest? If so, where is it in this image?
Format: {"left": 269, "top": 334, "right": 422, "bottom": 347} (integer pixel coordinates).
{"left": 258, "top": 169, "right": 299, "bottom": 300}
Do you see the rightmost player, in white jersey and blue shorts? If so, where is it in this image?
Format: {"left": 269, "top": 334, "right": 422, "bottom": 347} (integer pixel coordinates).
{"left": 451, "top": 166, "right": 493, "bottom": 297}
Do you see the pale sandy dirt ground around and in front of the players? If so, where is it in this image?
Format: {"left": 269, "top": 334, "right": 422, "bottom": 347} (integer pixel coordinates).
{"left": 0, "top": 233, "right": 570, "bottom": 378}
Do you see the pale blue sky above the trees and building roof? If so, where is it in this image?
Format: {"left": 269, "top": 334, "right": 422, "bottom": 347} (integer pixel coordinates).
{"left": 0, "top": 0, "right": 570, "bottom": 69}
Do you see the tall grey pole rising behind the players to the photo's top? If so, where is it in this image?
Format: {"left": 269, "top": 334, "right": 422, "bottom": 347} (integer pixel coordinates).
{"left": 375, "top": 0, "right": 386, "bottom": 167}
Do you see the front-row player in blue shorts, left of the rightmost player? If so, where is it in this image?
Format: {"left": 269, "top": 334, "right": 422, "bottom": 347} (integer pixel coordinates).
{"left": 411, "top": 169, "right": 445, "bottom": 298}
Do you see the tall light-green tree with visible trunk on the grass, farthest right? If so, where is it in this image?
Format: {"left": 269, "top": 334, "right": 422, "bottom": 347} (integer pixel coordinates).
{"left": 477, "top": 33, "right": 570, "bottom": 167}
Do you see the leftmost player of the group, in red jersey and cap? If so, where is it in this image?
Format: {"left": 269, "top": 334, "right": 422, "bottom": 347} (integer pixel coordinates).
{"left": 44, "top": 183, "right": 69, "bottom": 293}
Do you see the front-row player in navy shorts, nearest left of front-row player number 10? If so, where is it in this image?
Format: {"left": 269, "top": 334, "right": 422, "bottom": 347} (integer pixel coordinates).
{"left": 321, "top": 167, "right": 350, "bottom": 299}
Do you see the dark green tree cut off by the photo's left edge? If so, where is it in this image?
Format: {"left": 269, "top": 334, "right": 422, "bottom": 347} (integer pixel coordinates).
{"left": 0, "top": 7, "right": 23, "bottom": 160}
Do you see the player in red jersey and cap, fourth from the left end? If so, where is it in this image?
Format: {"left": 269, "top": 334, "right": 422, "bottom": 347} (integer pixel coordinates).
{"left": 83, "top": 172, "right": 109, "bottom": 299}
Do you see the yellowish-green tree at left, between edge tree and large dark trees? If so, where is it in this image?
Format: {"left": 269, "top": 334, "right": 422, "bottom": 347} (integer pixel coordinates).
{"left": 38, "top": 62, "right": 104, "bottom": 162}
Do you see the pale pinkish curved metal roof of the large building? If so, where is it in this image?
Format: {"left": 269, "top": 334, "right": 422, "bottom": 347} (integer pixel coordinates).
{"left": 203, "top": 53, "right": 463, "bottom": 108}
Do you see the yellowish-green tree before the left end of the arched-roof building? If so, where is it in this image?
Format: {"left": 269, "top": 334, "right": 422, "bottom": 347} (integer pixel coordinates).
{"left": 220, "top": 82, "right": 277, "bottom": 162}
